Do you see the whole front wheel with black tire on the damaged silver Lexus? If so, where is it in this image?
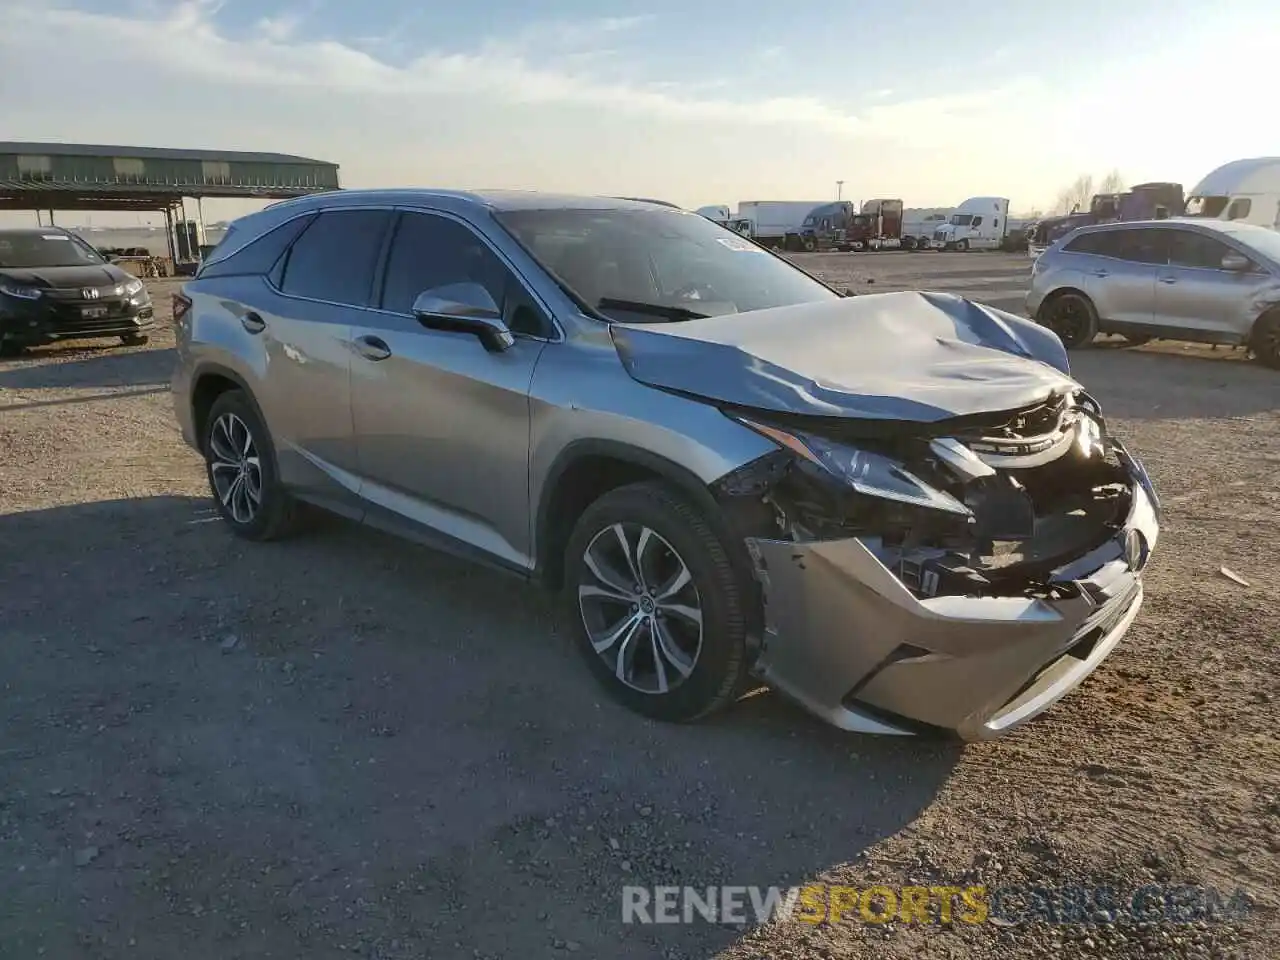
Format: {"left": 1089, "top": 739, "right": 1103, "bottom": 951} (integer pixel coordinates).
{"left": 563, "top": 483, "right": 748, "bottom": 723}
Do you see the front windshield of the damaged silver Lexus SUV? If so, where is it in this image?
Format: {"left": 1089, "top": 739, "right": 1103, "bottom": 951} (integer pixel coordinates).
{"left": 497, "top": 210, "right": 840, "bottom": 323}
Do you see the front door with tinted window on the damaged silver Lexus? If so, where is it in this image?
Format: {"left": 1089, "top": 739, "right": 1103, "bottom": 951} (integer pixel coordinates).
{"left": 351, "top": 211, "right": 547, "bottom": 567}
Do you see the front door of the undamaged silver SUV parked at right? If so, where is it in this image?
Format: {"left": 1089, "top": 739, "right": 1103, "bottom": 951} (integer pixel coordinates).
{"left": 1156, "top": 229, "right": 1266, "bottom": 343}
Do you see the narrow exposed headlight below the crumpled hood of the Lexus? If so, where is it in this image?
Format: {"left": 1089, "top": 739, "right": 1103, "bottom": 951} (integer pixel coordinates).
{"left": 735, "top": 417, "right": 973, "bottom": 517}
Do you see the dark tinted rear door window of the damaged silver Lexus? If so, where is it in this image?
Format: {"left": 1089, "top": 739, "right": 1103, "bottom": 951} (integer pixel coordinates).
{"left": 280, "top": 210, "right": 392, "bottom": 307}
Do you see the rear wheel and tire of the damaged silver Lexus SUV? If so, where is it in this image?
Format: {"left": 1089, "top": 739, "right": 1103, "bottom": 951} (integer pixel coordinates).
{"left": 200, "top": 390, "right": 301, "bottom": 540}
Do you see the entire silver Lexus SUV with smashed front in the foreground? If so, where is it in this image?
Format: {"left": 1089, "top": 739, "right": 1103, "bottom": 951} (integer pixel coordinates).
{"left": 174, "top": 191, "right": 1158, "bottom": 739}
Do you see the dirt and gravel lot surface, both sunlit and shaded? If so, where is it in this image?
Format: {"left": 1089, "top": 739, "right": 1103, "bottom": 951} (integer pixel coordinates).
{"left": 0, "top": 253, "right": 1280, "bottom": 960}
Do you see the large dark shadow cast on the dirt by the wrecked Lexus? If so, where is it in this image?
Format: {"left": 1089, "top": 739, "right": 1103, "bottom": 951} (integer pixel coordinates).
{"left": 0, "top": 497, "right": 959, "bottom": 960}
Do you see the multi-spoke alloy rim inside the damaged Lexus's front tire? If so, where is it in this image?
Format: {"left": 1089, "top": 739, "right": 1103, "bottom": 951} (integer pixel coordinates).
{"left": 577, "top": 524, "right": 703, "bottom": 695}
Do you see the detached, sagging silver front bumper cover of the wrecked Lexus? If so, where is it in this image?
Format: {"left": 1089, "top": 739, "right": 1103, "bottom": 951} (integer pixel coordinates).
{"left": 748, "top": 442, "right": 1160, "bottom": 740}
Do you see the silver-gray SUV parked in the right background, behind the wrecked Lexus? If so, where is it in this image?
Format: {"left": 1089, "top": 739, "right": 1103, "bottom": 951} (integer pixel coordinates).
{"left": 1027, "top": 219, "right": 1280, "bottom": 367}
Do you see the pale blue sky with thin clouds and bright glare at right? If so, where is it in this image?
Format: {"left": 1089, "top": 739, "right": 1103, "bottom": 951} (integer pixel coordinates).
{"left": 0, "top": 0, "right": 1280, "bottom": 223}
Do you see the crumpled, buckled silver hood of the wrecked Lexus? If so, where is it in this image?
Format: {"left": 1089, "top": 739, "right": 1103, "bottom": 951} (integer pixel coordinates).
{"left": 611, "top": 292, "right": 1079, "bottom": 422}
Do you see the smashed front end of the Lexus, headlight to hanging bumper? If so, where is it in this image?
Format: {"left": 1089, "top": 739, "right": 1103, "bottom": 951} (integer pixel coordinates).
{"left": 714, "top": 390, "right": 1160, "bottom": 740}
